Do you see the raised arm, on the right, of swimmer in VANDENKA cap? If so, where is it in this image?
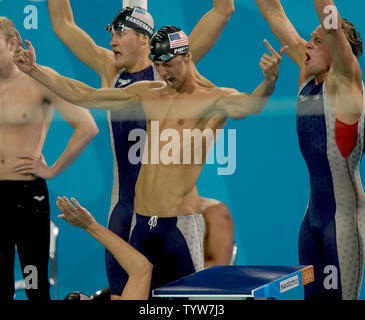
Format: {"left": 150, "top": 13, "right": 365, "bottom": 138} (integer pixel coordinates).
{"left": 189, "top": 0, "right": 234, "bottom": 64}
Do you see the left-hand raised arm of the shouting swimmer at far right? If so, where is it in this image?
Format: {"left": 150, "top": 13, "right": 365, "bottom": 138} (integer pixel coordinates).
{"left": 255, "top": 0, "right": 306, "bottom": 69}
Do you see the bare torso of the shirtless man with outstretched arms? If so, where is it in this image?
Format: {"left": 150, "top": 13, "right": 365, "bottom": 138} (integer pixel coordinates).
{"left": 135, "top": 87, "right": 226, "bottom": 217}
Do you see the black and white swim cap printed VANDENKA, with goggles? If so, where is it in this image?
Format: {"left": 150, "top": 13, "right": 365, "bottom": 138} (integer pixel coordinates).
{"left": 106, "top": 7, "right": 155, "bottom": 38}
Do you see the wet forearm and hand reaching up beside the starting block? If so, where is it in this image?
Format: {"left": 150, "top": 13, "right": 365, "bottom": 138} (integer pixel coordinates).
{"left": 56, "top": 197, "right": 152, "bottom": 300}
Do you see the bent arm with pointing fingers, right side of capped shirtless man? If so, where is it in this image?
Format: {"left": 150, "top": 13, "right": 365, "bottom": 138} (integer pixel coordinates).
{"left": 217, "top": 40, "right": 287, "bottom": 120}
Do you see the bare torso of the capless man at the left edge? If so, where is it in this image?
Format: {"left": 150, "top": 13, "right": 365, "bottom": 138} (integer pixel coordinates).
{"left": 0, "top": 74, "right": 54, "bottom": 180}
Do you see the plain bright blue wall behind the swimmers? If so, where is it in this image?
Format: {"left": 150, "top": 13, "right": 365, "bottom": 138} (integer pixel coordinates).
{"left": 0, "top": 0, "right": 365, "bottom": 299}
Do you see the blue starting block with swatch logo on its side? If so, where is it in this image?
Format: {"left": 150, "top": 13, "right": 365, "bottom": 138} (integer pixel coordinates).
{"left": 152, "top": 266, "right": 314, "bottom": 300}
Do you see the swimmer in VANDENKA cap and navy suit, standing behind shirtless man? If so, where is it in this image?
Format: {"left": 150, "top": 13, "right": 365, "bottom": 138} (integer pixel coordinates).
{"left": 48, "top": 0, "right": 234, "bottom": 299}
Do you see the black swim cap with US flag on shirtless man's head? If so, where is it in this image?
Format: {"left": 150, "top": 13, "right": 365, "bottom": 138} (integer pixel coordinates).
{"left": 149, "top": 26, "right": 190, "bottom": 62}
